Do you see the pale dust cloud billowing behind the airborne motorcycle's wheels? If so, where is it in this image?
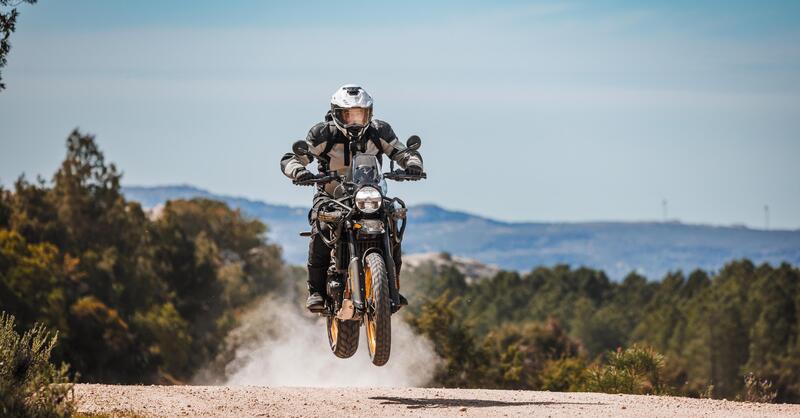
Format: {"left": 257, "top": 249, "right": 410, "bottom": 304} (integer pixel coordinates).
{"left": 219, "top": 297, "right": 440, "bottom": 387}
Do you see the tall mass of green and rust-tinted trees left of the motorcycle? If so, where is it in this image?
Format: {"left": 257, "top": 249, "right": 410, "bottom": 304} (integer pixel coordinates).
{"left": 0, "top": 130, "right": 285, "bottom": 383}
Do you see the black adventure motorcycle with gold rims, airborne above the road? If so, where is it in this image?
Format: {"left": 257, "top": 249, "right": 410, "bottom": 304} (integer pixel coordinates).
{"left": 292, "top": 135, "right": 427, "bottom": 366}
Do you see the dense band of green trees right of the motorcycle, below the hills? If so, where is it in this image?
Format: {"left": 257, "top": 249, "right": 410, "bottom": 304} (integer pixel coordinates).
{"left": 404, "top": 260, "right": 800, "bottom": 401}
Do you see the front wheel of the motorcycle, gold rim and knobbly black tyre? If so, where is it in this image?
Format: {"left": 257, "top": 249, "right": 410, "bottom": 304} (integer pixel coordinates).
{"left": 364, "top": 253, "right": 392, "bottom": 366}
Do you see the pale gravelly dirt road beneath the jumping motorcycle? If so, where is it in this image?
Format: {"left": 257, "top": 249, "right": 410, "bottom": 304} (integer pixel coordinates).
{"left": 75, "top": 385, "right": 800, "bottom": 418}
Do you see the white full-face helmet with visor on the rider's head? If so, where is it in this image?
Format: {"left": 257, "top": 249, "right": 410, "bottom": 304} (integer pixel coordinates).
{"left": 331, "top": 84, "right": 372, "bottom": 139}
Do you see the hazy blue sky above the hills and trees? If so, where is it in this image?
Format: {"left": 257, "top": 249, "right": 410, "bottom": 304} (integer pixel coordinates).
{"left": 0, "top": 0, "right": 800, "bottom": 229}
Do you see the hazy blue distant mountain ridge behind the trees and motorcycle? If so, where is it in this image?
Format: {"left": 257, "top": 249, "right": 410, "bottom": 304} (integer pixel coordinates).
{"left": 123, "top": 185, "right": 800, "bottom": 279}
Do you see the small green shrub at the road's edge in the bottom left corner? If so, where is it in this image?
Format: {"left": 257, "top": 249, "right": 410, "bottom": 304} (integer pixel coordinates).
{"left": 0, "top": 312, "right": 75, "bottom": 417}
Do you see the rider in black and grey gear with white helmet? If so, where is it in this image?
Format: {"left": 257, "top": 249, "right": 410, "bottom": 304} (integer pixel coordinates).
{"left": 281, "top": 84, "right": 422, "bottom": 311}
